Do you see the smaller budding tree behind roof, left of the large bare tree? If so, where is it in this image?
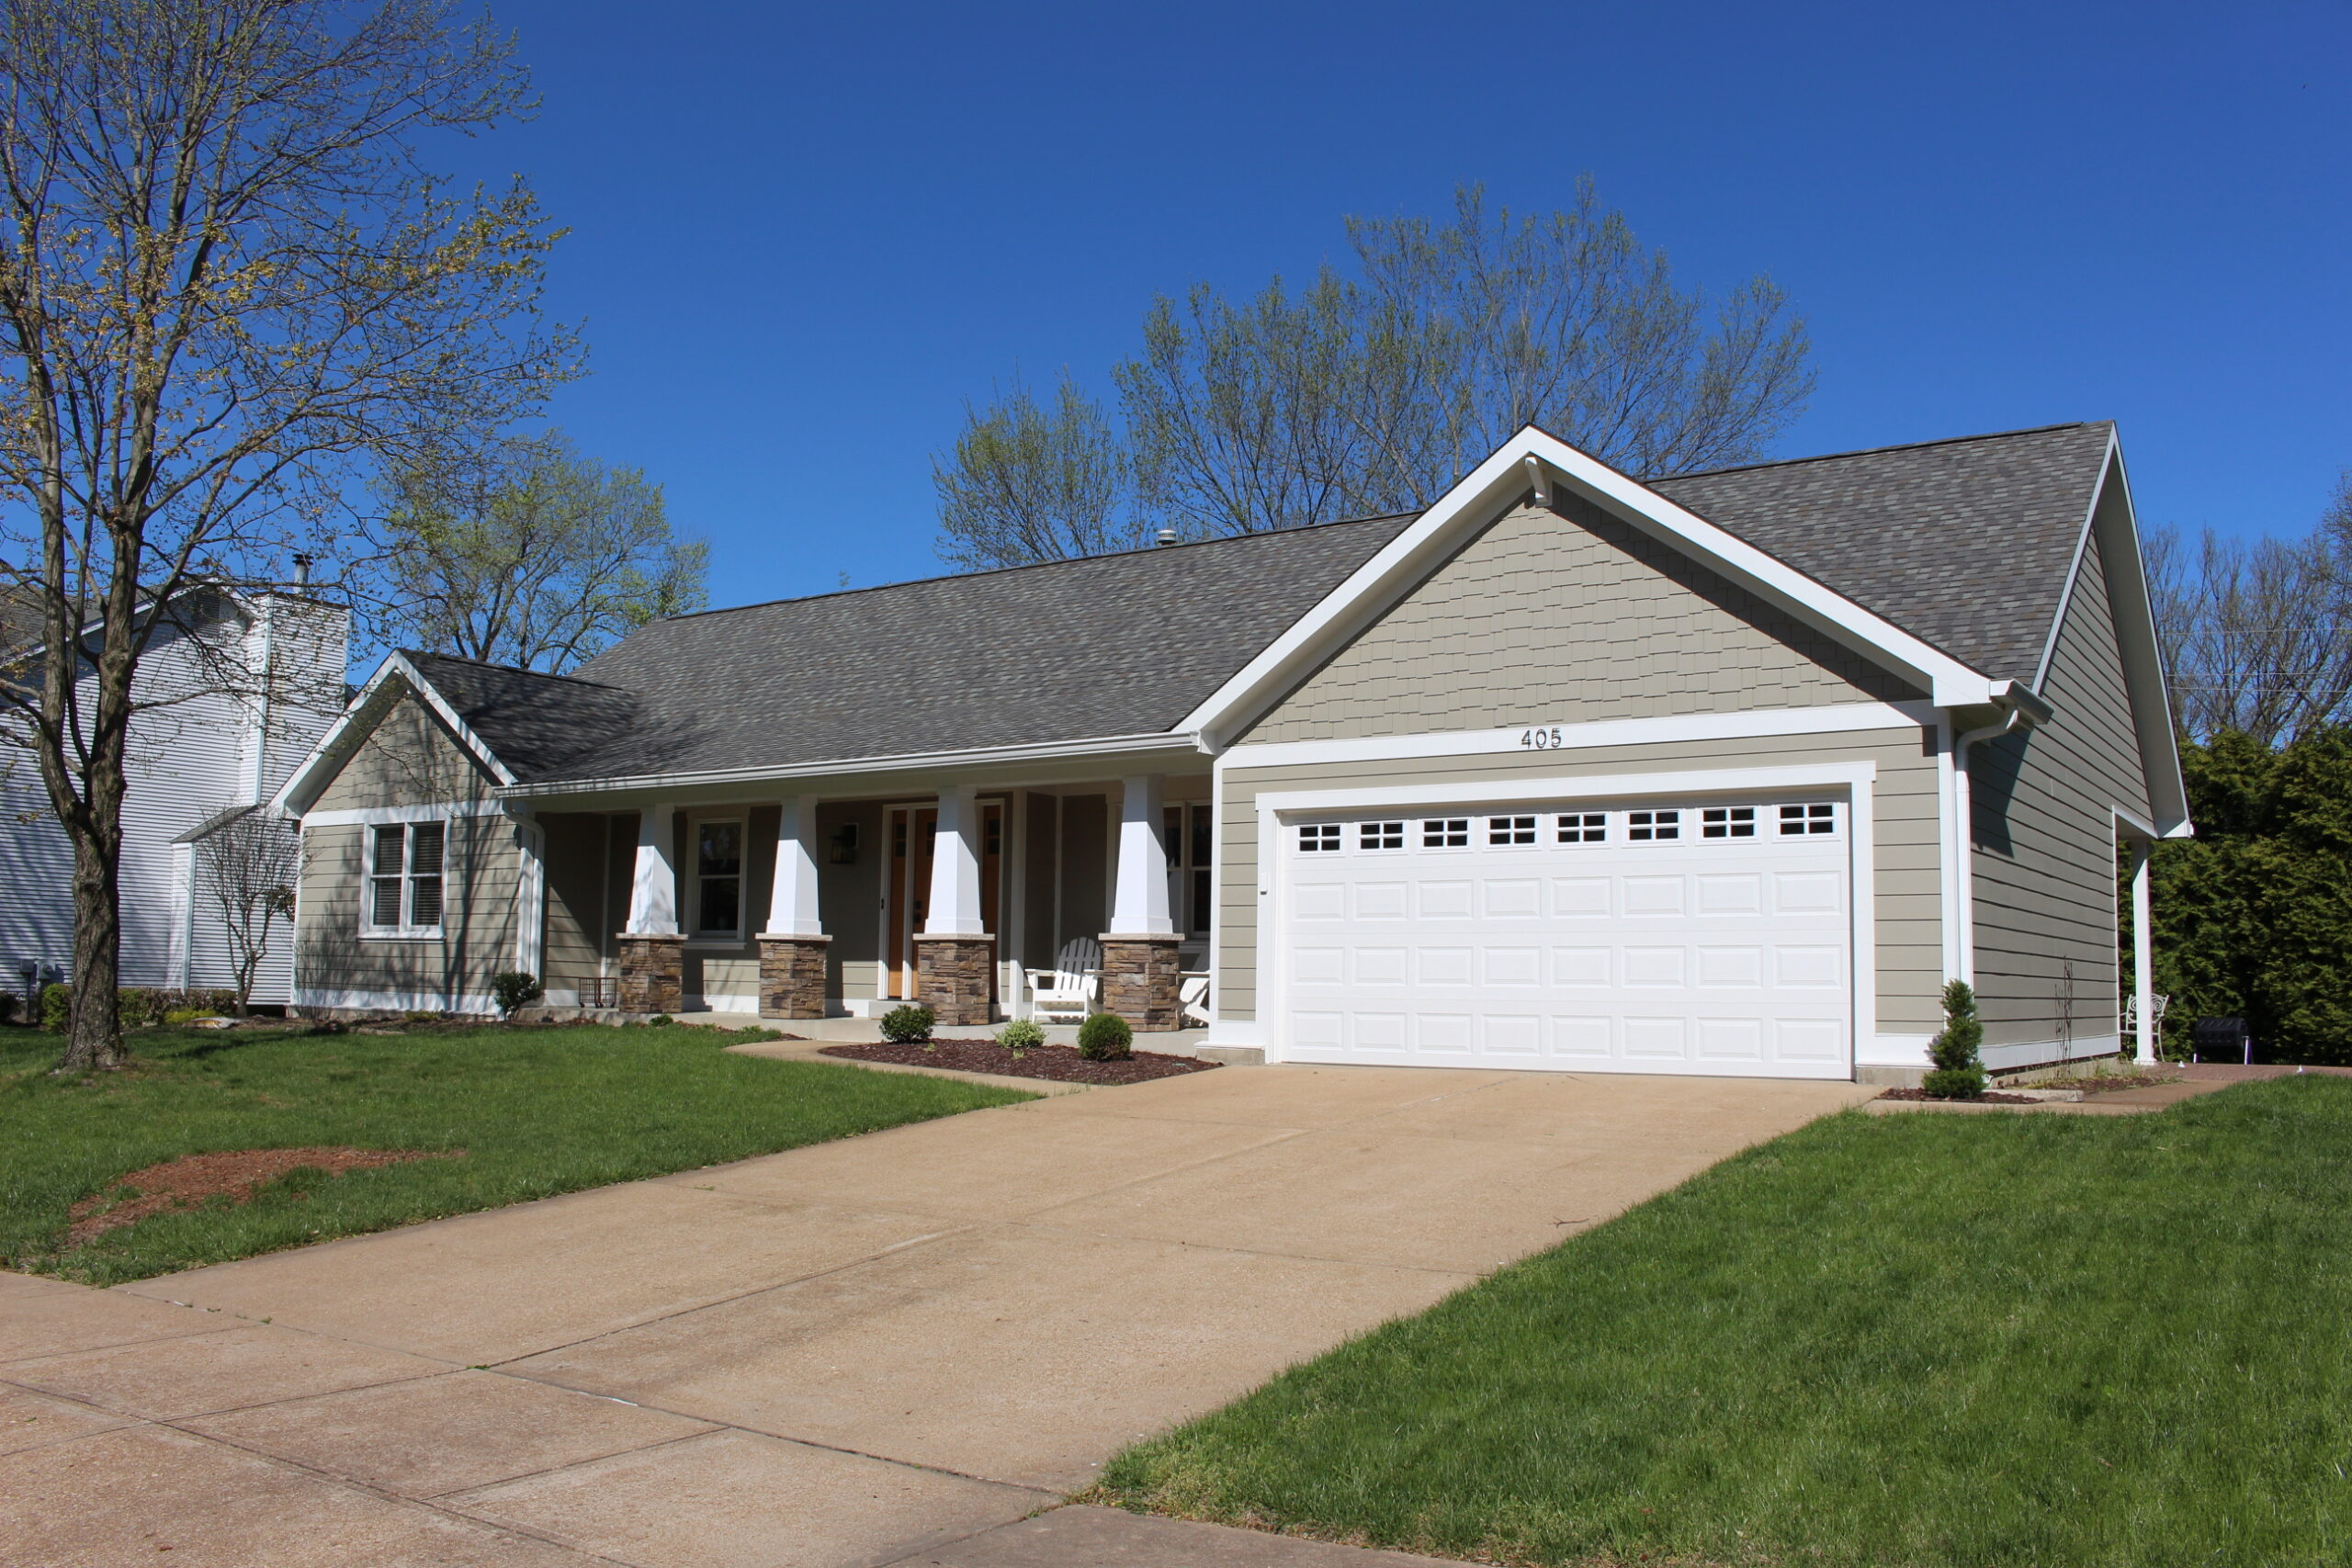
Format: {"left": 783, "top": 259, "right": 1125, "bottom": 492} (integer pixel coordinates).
{"left": 932, "top": 371, "right": 1141, "bottom": 569}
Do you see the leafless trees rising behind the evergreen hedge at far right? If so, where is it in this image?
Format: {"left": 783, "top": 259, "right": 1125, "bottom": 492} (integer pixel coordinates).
{"left": 2147, "top": 475, "right": 2352, "bottom": 745}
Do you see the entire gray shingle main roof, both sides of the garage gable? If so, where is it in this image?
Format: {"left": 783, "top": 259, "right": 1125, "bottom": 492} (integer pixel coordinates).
{"left": 409, "top": 423, "right": 2109, "bottom": 783}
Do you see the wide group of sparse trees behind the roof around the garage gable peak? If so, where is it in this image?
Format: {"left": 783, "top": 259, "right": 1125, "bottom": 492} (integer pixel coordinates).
{"left": 933, "top": 179, "right": 1814, "bottom": 564}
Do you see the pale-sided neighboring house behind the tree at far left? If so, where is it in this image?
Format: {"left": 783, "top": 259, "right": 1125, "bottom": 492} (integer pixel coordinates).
{"left": 0, "top": 583, "right": 350, "bottom": 1004}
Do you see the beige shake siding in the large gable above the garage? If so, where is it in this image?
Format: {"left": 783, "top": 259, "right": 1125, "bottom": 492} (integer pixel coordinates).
{"left": 1247, "top": 499, "right": 1922, "bottom": 740}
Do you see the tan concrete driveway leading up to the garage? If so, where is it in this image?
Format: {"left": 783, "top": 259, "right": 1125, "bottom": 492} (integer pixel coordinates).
{"left": 0, "top": 1067, "right": 1872, "bottom": 1568}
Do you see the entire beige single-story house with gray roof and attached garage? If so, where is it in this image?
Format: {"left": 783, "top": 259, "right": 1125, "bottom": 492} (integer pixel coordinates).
{"left": 280, "top": 423, "right": 2188, "bottom": 1079}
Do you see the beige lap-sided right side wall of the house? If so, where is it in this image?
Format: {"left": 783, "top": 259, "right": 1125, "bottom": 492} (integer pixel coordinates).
{"left": 1969, "top": 514, "right": 2152, "bottom": 1058}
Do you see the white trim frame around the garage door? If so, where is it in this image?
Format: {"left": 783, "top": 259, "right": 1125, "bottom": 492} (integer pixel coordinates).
{"left": 1241, "top": 761, "right": 1882, "bottom": 1077}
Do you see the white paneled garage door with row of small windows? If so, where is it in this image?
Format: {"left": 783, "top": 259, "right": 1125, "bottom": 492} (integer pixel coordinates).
{"left": 1277, "top": 799, "right": 1853, "bottom": 1079}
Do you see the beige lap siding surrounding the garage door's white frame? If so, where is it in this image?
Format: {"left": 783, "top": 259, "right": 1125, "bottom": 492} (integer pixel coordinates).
{"left": 1216, "top": 728, "right": 1943, "bottom": 1034}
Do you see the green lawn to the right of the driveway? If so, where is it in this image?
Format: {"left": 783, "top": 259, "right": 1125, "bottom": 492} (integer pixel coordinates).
{"left": 1101, "top": 1077, "right": 2352, "bottom": 1568}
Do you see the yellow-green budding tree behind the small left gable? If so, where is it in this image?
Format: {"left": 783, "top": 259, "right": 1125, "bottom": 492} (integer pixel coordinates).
{"left": 381, "top": 430, "right": 710, "bottom": 674}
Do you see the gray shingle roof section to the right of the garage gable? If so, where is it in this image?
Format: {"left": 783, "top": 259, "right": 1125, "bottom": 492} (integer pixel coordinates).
{"left": 1651, "top": 421, "right": 2114, "bottom": 682}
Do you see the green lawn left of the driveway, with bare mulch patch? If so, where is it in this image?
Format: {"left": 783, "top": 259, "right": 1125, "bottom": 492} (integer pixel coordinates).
{"left": 0, "top": 1027, "right": 1033, "bottom": 1283}
